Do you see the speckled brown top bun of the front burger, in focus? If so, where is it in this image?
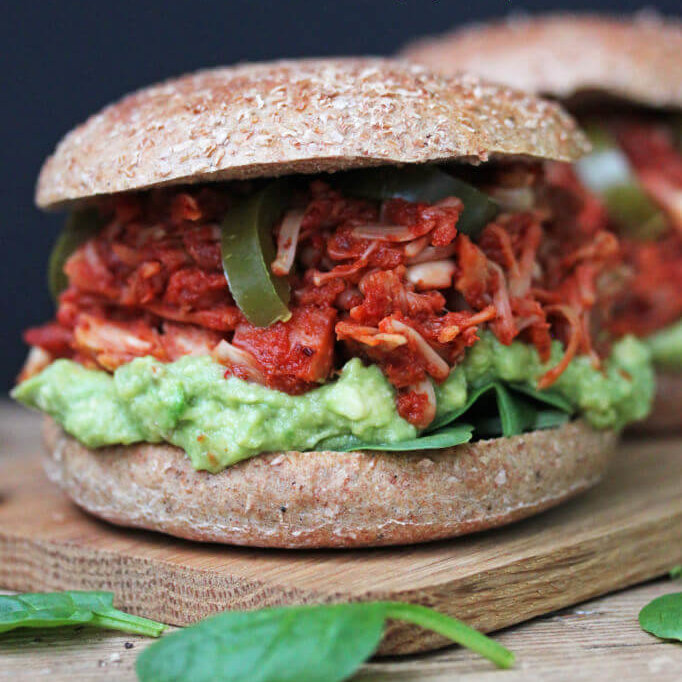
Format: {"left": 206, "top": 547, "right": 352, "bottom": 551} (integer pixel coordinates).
{"left": 36, "top": 58, "right": 587, "bottom": 208}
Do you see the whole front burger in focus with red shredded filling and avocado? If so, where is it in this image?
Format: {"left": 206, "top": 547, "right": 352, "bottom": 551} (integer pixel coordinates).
{"left": 13, "top": 58, "right": 653, "bottom": 547}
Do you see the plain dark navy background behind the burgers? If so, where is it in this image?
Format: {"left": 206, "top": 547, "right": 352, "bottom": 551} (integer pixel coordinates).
{"left": 0, "top": 0, "right": 680, "bottom": 388}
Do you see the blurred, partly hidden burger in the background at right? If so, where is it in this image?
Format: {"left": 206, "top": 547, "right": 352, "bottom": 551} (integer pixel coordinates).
{"left": 405, "top": 13, "right": 682, "bottom": 432}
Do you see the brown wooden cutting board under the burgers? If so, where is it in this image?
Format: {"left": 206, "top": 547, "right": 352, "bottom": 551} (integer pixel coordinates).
{"left": 0, "top": 408, "right": 682, "bottom": 653}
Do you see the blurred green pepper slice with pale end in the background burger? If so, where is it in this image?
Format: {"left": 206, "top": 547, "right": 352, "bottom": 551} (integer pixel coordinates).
{"left": 575, "top": 125, "right": 667, "bottom": 240}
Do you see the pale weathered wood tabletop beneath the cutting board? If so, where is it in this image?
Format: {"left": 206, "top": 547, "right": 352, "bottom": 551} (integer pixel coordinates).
{"left": 0, "top": 580, "right": 682, "bottom": 682}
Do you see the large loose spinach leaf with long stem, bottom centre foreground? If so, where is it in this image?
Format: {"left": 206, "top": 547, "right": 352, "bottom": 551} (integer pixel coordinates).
{"left": 136, "top": 602, "right": 514, "bottom": 682}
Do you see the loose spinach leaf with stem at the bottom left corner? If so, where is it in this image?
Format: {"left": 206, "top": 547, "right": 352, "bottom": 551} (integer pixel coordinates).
{"left": 0, "top": 591, "right": 166, "bottom": 637}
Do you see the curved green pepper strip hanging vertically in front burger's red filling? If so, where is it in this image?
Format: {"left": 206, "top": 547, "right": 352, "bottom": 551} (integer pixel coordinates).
{"left": 221, "top": 180, "right": 293, "bottom": 327}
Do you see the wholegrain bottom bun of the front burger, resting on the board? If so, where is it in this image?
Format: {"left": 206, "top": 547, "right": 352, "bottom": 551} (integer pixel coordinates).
{"left": 45, "top": 420, "right": 617, "bottom": 548}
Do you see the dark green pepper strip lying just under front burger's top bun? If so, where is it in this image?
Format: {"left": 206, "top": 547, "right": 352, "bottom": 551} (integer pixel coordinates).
{"left": 332, "top": 166, "right": 499, "bottom": 237}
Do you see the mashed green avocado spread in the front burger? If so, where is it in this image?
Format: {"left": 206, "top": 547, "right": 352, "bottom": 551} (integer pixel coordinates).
{"left": 12, "top": 332, "right": 653, "bottom": 472}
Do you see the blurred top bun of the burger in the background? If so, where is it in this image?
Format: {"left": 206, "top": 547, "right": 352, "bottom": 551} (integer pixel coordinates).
{"left": 403, "top": 13, "right": 682, "bottom": 109}
